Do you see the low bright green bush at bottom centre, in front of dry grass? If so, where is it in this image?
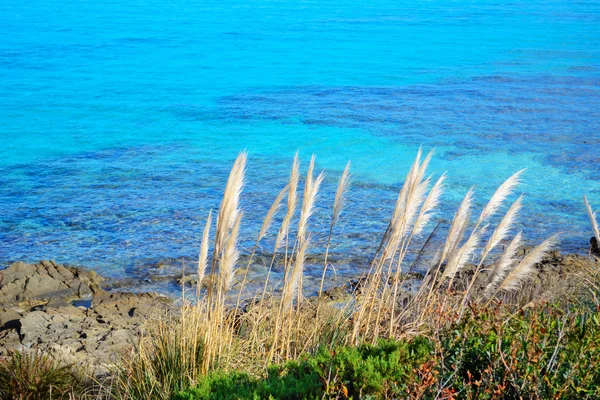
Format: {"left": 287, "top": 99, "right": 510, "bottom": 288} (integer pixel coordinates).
{"left": 175, "top": 338, "right": 433, "bottom": 400}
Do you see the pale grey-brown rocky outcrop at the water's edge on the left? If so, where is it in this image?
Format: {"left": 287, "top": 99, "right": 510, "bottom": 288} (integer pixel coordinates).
{"left": 0, "top": 261, "right": 174, "bottom": 376}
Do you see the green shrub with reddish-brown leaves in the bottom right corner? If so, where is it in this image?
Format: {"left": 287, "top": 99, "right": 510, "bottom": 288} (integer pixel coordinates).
{"left": 438, "top": 306, "right": 600, "bottom": 399}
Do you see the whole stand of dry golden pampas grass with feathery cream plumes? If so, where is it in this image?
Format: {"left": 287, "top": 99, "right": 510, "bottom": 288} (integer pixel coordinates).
{"left": 119, "top": 150, "right": 584, "bottom": 399}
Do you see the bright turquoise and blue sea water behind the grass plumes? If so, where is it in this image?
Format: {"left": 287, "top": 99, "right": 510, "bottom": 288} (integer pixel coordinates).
{"left": 0, "top": 0, "right": 600, "bottom": 291}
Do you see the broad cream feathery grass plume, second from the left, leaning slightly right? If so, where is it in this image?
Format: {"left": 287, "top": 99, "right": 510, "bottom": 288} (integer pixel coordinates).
{"left": 213, "top": 151, "right": 247, "bottom": 265}
